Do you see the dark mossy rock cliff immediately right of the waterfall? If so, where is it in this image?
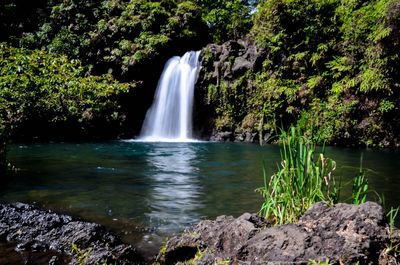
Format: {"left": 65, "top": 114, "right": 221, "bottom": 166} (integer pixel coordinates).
{"left": 194, "top": 39, "right": 265, "bottom": 142}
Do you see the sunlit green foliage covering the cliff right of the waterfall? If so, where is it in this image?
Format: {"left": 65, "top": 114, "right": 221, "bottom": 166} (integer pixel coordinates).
{"left": 205, "top": 0, "right": 400, "bottom": 146}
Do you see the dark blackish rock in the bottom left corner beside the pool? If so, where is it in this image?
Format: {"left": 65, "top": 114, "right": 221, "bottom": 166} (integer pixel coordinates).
{"left": 0, "top": 203, "right": 143, "bottom": 264}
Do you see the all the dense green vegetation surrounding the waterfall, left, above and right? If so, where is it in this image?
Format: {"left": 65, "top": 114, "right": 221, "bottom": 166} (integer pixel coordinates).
{"left": 0, "top": 0, "right": 400, "bottom": 153}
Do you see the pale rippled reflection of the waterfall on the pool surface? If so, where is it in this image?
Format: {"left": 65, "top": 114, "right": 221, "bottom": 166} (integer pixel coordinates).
{"left": 145, "top": 143, "right": 202, "bottom": 233}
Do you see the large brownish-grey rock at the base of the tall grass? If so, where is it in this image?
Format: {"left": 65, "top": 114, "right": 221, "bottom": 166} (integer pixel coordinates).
{"left": 158, "top": 202, "right": 399, "bottom": 264}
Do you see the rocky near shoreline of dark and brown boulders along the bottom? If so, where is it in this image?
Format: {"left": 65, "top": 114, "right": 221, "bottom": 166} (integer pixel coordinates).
{"left": 0, "top": 202, "right": 400, "bottom": 265}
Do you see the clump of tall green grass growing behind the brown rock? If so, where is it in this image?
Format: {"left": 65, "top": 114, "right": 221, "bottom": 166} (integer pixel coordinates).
{"left": 258, "top": 127, "right": 339, "bottom": 224}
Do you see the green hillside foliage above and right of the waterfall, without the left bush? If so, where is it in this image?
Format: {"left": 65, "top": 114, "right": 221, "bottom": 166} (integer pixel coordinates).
{"left": 0, "top": 0, "right": 400, "bottom": 146}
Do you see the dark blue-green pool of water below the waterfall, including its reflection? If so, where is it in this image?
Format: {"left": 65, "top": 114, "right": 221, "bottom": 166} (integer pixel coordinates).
{"left": 0, "top": 141, "right": 400, "bottom": 254}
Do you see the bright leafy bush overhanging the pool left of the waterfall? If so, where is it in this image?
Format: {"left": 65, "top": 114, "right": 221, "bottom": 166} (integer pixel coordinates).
{"left": 0, "top": 43, "right": 131, "bottom": 138}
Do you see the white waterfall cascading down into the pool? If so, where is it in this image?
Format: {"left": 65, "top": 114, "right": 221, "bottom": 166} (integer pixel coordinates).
{"left": 140, "top": 51, "right": 200, "bottom": 142}
